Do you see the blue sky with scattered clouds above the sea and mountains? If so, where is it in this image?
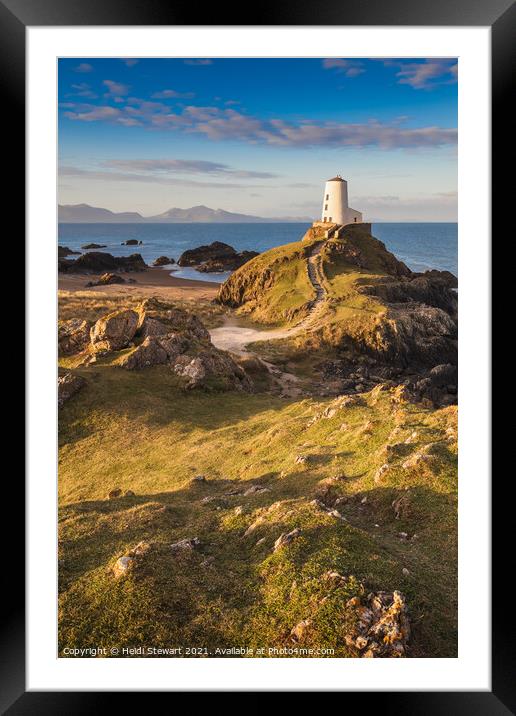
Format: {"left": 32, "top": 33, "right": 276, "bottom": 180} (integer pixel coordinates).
{"left": 59, "top": 58, "right": 457, "bottom": 221}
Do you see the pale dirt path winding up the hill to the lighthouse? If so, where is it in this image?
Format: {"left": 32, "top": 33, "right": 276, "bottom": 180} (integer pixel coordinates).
{"left": 210, "top": 241, "right": 326, "bottom": 397}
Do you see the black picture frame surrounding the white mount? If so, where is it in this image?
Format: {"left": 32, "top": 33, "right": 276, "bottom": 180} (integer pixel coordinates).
{"left": 7, "top": 0, "right": 508, "bottom": 716}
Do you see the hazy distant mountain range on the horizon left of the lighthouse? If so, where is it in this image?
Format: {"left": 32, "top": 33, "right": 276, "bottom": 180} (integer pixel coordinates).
{"left": 58, "top": 204, "right": 312, "bottom": 224}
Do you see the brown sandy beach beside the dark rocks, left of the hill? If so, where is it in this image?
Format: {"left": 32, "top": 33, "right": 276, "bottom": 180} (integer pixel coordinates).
{"left": 58, "top": 268, "right": 219, "bottom": 300}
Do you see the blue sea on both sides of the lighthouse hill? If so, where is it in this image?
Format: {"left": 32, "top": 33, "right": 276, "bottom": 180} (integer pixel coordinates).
{"left": 58, "top": 222, "right": 458, "bottom": 283}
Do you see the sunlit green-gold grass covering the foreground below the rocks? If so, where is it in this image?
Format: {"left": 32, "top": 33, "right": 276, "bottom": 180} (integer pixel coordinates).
{"left": 59, "top": 364, "right": 457, "bottom": 657}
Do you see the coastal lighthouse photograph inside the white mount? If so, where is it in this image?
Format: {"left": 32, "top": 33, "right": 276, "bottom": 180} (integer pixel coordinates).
{"left": 58, "top": 54, "right": 458, "bottom": 666}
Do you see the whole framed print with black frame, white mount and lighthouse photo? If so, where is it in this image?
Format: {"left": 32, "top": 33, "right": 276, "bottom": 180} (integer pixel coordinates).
{"left": 6, "top": 1, "right": 514, "bottom": 714}
